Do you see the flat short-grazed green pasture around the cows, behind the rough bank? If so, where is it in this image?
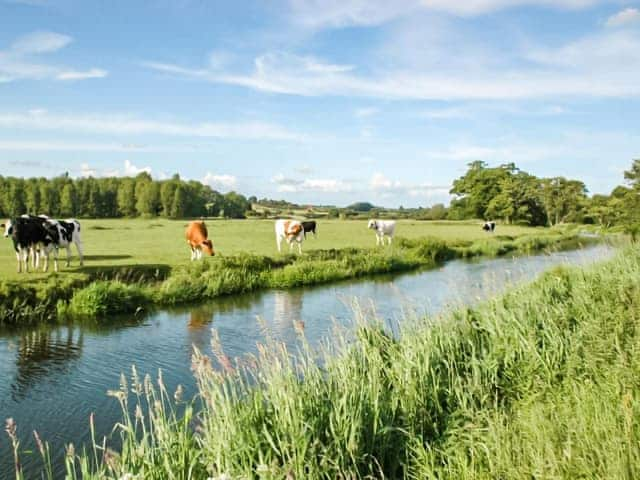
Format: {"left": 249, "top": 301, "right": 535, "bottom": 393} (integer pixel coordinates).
{"left": 0, "top": 219, "right": 548, "bottom": 281}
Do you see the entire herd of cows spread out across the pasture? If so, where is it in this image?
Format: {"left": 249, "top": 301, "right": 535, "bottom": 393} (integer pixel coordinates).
{"left": 0, "top": 215, "right": 496, "bottom": 272}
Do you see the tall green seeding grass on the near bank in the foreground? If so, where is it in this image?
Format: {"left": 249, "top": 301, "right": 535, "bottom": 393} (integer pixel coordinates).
{"left": 10, "top": 240, "right": 640, "bottom": 479}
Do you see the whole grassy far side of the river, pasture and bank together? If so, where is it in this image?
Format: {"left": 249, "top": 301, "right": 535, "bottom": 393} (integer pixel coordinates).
{"left": 0, "top": 220, "right": 588, "bottom": 325}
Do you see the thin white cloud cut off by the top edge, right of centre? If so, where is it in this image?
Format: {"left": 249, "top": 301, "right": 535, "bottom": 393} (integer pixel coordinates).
{"left": 289, "top": 0, "right": 609, "bottom": 29}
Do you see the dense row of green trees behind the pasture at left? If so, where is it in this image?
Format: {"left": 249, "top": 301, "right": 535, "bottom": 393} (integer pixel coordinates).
{"left": 0, "top": 172, "right": 251, "bottom": 218}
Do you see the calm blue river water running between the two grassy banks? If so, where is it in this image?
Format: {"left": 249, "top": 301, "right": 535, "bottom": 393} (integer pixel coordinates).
{"left": 0, "top": 246, "right": 613, "bottom": 478}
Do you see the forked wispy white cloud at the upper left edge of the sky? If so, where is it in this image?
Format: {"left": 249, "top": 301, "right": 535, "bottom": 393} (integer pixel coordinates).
{"left": 0, "top": 32, "right": 108, "bottom": 83}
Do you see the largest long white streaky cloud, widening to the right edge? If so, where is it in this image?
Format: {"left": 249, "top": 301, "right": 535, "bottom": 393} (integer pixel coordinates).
{"left": 147, "top": 31, "right": 640, "bottom": 100}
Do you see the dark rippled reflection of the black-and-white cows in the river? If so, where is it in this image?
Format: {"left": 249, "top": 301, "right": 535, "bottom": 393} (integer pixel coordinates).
{"left": 12, "top": 327, "right": 84, "bottom": 398}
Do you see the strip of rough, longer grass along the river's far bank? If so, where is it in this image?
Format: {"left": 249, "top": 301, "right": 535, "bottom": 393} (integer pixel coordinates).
{"left": 0, "top": 231, "right": 597, "bottom": 325}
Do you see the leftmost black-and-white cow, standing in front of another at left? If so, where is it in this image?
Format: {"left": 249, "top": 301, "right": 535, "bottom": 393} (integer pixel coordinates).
{"left": 0, "top": 216, "right": 58, "bottom": 273}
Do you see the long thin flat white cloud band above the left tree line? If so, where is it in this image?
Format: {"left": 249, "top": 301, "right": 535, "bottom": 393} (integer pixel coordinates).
{"left": 0, "top": 112, "right": 306, "bottom": 141}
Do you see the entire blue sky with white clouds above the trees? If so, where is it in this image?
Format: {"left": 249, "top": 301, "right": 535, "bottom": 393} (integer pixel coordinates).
{"left": 0, "top": 0, "right": 640, "bottom": 206}
